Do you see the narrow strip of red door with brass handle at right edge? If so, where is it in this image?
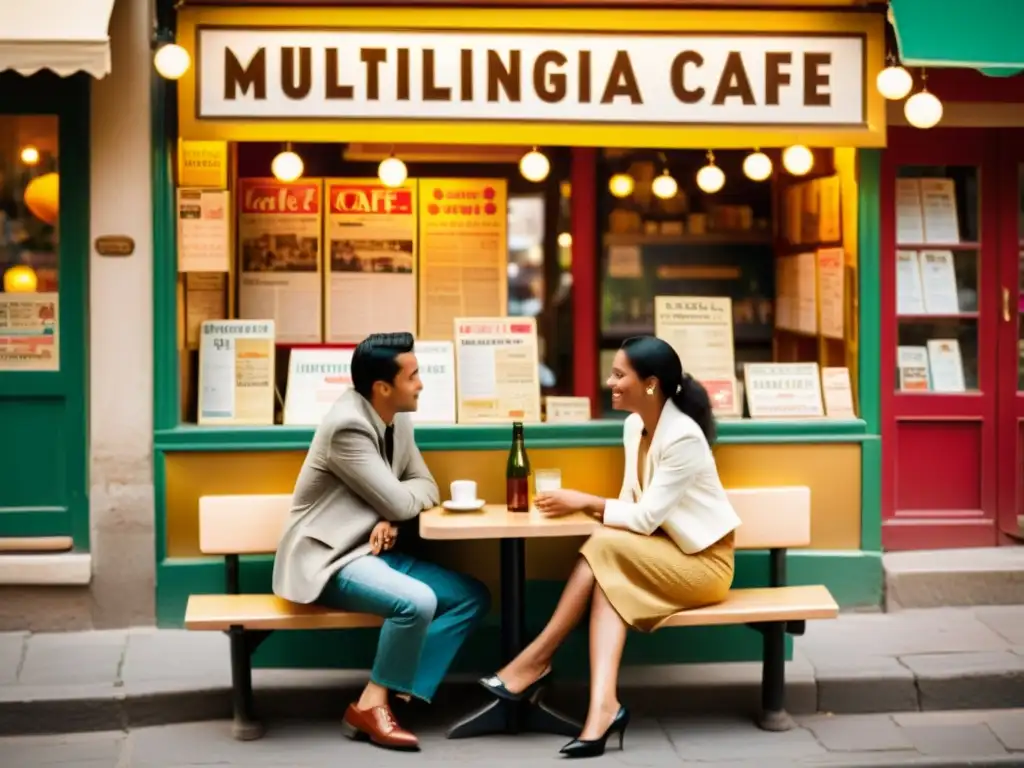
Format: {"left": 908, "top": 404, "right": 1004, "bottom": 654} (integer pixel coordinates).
{"left": 996, "top": 130, "right": 1024, "bottom": 543}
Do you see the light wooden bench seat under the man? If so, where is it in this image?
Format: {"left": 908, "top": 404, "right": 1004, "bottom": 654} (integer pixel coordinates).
{"left": 185, "top": 595, "right": 384, "bottom": 632}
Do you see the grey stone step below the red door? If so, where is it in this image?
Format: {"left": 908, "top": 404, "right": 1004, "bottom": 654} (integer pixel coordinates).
{"left": 882, "top": 546, "right": 1024, "bottom": 611}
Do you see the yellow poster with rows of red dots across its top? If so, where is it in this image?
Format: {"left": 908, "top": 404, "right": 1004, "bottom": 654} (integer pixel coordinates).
{"left": 418, "top": 178, "right": 508, "bottom": 341}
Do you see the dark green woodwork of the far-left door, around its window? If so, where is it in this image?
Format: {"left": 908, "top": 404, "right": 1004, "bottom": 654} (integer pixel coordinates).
{"left": 0, "top": 73, "right": 90, "bottom": 551}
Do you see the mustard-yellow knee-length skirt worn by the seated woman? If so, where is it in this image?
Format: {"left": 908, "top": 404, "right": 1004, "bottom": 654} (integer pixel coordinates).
{"left": 580, "top": 528, "right": 735, "bottom": 632}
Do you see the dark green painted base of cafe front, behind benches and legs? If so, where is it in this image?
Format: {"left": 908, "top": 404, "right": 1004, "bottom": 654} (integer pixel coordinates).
{"left": 157, "top": 551, "right": 882, "bottom": 674}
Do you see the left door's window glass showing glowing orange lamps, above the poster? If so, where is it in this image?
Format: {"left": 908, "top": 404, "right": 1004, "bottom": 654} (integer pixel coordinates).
{"left": 0, "top": 115, "right": 59, "bottom": 293}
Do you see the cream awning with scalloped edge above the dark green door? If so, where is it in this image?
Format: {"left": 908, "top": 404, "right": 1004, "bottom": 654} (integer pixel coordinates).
{"left": 0, "top": 0, "right": 114, "bottom": 78}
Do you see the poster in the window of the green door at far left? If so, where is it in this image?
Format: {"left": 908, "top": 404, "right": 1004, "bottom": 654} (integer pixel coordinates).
{"left": 0, "top": 293, "right": 60, "bottom": 371}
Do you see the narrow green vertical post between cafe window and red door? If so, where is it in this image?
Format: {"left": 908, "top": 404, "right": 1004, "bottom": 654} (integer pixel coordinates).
{"left": 857, "top": 150, "right": 882, "bottom": 552}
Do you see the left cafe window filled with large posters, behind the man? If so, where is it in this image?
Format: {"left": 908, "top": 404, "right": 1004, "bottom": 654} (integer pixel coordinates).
{"left": 177, "top": 142, "right": 572, "bottom": 424}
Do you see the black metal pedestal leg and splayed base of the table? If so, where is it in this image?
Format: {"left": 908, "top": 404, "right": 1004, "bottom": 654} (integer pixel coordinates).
{"left": 447, "top": 539, "right": 583, "bottom": 738}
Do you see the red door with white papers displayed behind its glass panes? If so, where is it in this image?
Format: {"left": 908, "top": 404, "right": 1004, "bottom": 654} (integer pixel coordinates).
{"left": 881, "top": 128, "right": 999, "bottom": 550}
